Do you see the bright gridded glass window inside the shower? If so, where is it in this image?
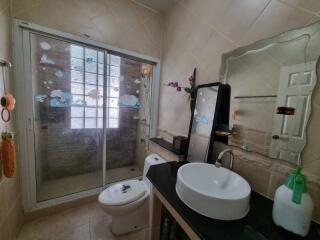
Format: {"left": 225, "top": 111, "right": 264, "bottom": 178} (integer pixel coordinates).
{"left": 70, "top": 51, "right": 121, "bottom": 129}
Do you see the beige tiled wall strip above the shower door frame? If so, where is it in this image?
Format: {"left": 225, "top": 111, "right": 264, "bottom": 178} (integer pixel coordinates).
{"left": 12, "top": 0, "right": 162, "bottom": 58}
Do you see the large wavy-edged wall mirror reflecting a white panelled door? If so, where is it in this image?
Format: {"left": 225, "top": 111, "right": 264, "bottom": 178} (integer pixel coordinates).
{"left": 220, "top": 23, "right": 320, "bottom": 164}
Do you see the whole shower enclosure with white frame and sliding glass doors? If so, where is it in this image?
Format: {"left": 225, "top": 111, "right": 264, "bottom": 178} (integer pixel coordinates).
{"left": 14, "top": 20, "right": 159, "bottom": 211}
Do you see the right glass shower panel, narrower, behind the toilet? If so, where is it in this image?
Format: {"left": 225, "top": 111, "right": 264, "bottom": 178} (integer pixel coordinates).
{"left": 105, "top": 54, "right": 153, "bottom": 184}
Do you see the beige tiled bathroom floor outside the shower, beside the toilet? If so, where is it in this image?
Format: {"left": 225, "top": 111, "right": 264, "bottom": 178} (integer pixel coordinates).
{"left": 17, "top": 202, "right": 148, "bottom": 240}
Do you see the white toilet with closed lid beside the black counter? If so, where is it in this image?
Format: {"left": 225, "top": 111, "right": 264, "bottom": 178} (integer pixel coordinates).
{"left": 99, "top": 154, "right": 165, "bottom": 234}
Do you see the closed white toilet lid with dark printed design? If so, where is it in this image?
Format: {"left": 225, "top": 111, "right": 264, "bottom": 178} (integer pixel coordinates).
{"left": 99, "top": 180, "right": 147, "bottom": 205}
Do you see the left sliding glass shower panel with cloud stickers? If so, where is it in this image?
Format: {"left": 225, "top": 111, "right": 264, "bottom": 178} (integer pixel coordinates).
{"left": 29, "top": 33, "right": 105, "bottom": 202}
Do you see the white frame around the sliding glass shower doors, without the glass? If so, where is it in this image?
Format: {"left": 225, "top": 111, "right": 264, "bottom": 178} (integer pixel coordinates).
{"left": 13, "top": 19, "right": 160, "bottom": 212}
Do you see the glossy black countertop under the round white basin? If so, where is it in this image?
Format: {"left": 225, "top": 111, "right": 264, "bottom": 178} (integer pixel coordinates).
{"left": 147, "top": 162, "right": 320, "bottom": 240}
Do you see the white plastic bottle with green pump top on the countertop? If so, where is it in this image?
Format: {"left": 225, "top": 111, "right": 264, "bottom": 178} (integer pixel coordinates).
{"left": 272, "top": 166, "right": 313, "bottom": 237}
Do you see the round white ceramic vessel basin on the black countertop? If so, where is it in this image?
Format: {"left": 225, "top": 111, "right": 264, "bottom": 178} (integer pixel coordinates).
{"left": 176, "top": 163, "right": 251, "bottom": 220}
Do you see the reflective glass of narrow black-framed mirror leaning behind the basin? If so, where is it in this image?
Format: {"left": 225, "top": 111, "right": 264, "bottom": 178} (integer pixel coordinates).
{"left": 187, "top": 83, "right": 219, "bottom": 162}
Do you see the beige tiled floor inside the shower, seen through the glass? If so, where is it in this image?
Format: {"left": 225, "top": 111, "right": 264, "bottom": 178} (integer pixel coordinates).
{"left": 37, "top": 165, "right": 142, "bottom": 202}
